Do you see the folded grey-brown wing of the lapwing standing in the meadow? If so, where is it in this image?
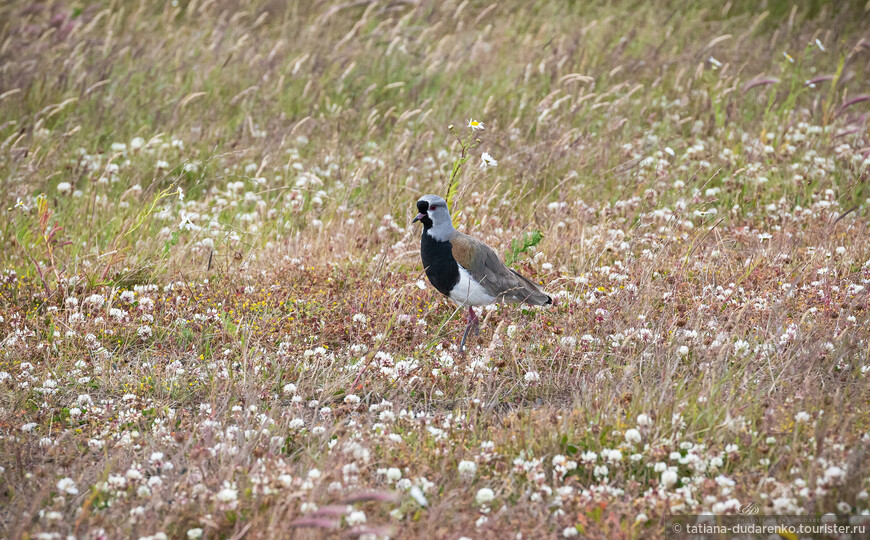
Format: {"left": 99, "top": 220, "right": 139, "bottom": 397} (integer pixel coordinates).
{"left": 450, "top": 233, "right": 552, "bottom": 306}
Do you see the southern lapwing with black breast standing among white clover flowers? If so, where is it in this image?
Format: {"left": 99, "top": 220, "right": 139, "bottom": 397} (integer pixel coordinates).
{"left": 411, "top": 195, "right": 553, "bottom": 352}
